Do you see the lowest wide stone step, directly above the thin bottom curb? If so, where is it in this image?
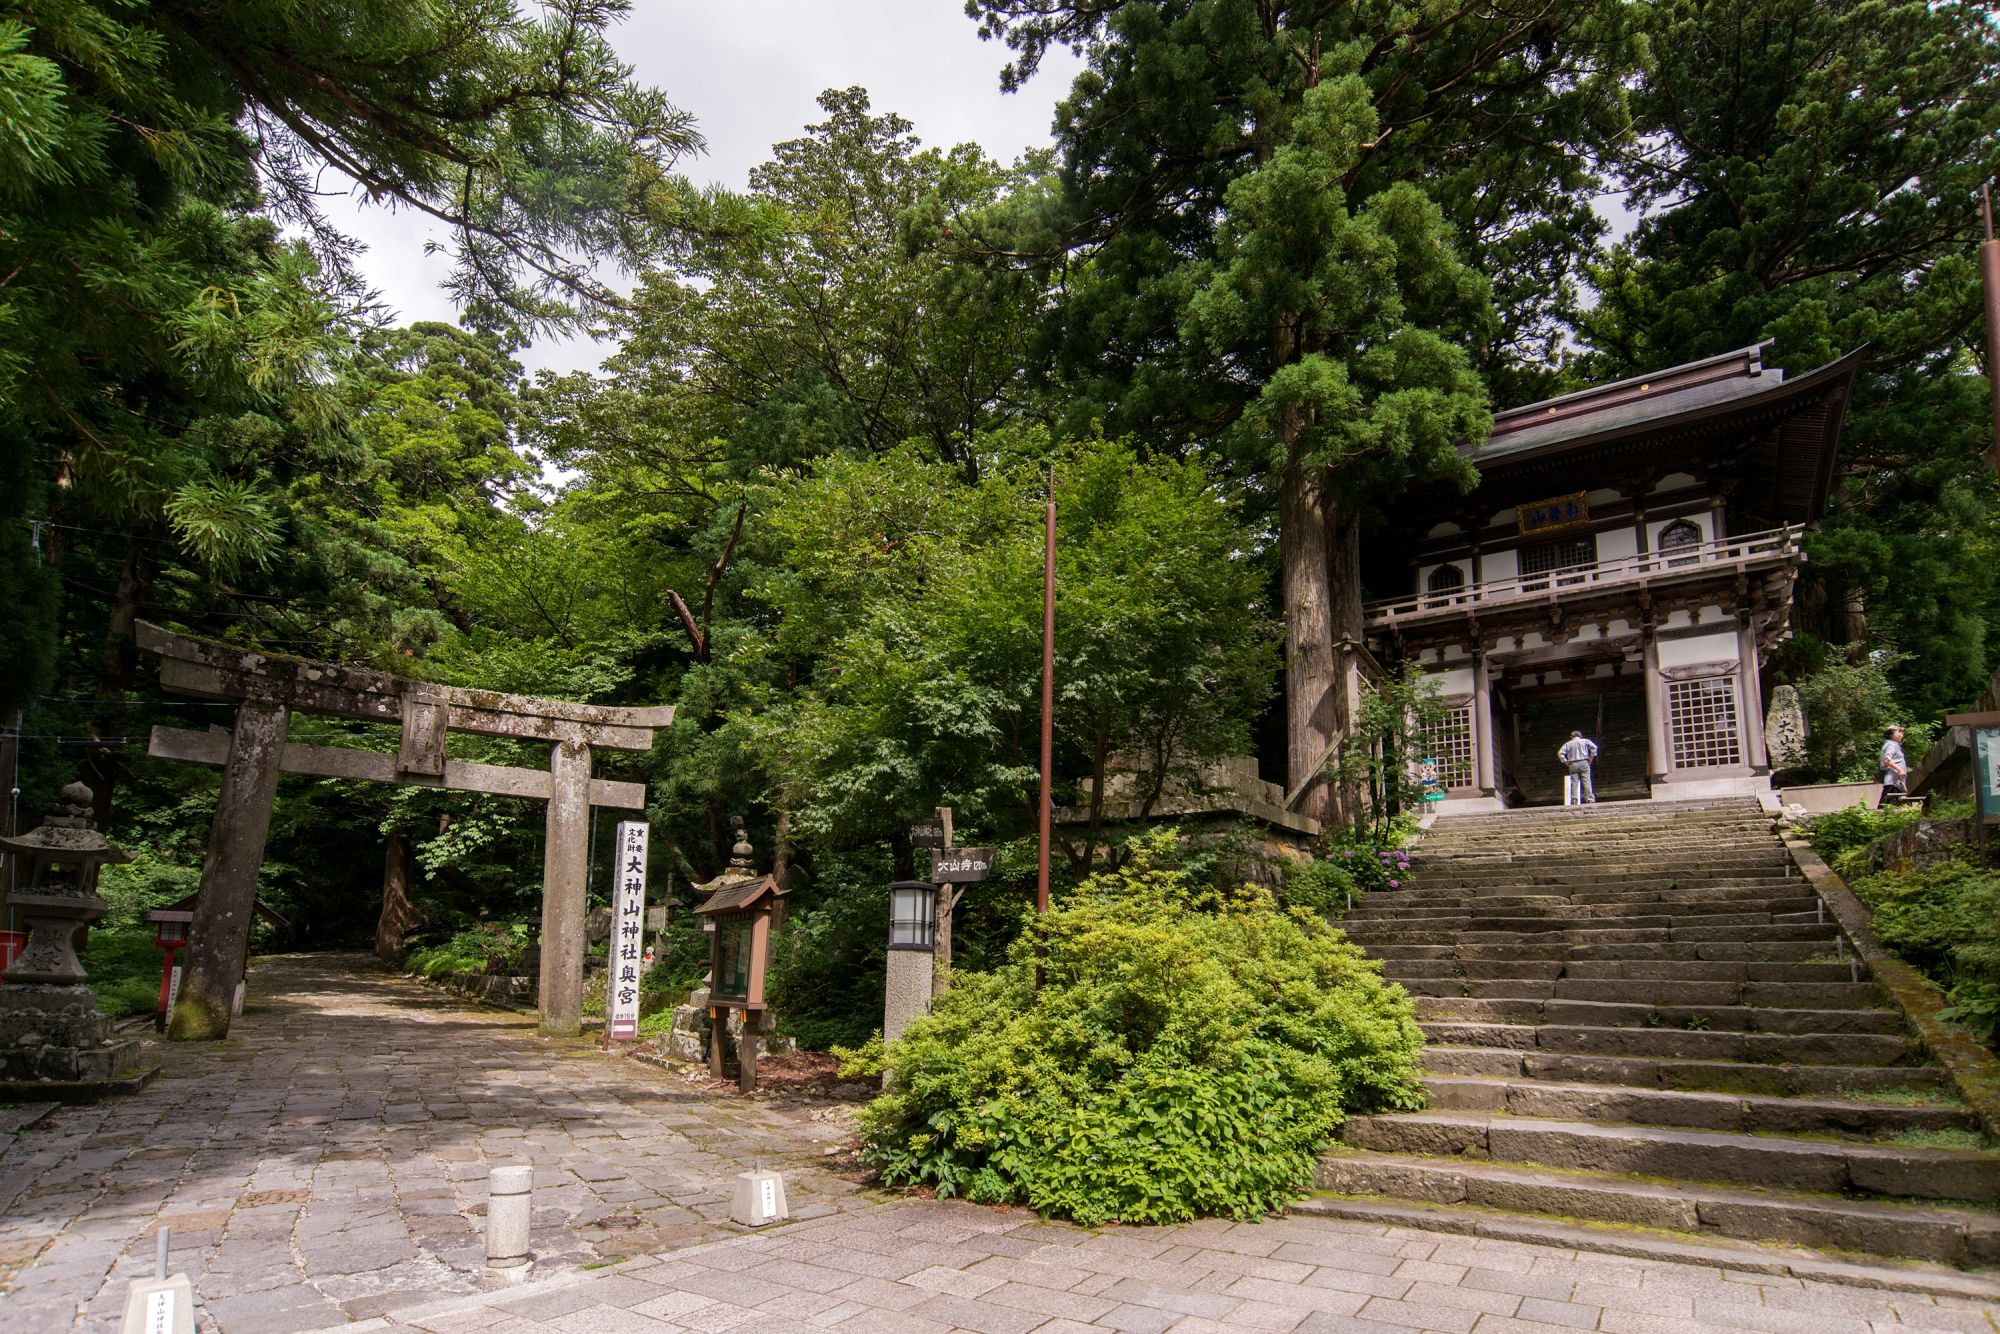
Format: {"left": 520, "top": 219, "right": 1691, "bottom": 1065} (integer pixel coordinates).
{"left": 1318, "top": 1152, "right": 2000, "bottom": 1272}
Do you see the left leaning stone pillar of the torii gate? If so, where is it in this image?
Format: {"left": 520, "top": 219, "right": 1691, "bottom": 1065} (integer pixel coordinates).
{"left": 166, "top": 700, "right": 292, "bottom": 1038}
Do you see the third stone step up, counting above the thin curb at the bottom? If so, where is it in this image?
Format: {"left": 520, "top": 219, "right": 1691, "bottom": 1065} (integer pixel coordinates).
{"left": 1424, "top": 1074, "right": 1980, "bottom": 1140}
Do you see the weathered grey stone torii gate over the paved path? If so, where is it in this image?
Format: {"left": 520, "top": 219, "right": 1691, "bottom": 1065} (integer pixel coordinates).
{"left": 136, "top": 622, "right": 674, "bottom": 1038}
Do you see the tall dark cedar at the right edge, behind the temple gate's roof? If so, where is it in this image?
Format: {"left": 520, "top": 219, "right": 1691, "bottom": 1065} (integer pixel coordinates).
{"left": 1582, "top": 0, "right": 2000, "bottom": 714}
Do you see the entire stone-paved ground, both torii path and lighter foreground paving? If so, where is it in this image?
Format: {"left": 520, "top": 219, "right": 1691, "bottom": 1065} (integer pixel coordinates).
{"left": 11, "top": 956, "right": 2000, "bottom": 1334}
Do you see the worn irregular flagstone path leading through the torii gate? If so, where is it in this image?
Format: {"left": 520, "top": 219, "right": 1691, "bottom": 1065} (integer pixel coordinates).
{"left": 0, "top": 954, "right": 868, "bottom": 1334}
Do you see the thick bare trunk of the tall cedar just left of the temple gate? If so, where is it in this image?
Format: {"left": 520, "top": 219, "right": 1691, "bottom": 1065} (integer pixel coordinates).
{"left": 1278, "top": 460, "right": 1340, "bottom": 824}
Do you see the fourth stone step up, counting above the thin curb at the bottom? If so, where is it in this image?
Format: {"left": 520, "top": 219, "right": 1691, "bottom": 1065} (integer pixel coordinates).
{"left": 1422, "top": 1044, "right": 1948, "bottom": 1100}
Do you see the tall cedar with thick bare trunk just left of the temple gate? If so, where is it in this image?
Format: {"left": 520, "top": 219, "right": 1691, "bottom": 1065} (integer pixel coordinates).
{"left": 968, "top": 0, "right": 1630, "bottom": 818}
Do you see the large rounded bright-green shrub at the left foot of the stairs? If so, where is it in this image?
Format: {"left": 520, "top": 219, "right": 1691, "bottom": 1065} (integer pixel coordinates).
{"left": 862, "top": 842, "right": 1422, "bottom": 1224}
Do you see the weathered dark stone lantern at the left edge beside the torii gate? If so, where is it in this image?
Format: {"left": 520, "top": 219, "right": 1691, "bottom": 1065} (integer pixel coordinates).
{"left": 0, "top": 782, "right": 138, "bottom": 1090}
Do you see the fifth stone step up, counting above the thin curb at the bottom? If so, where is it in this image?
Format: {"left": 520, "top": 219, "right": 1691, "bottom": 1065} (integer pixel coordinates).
{"left": 1418, "top": 1020, "right": 1920, "bottom": 1066}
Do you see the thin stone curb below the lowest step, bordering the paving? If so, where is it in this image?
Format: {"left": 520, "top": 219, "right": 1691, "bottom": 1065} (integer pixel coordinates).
{"left": 1290, "top": 1194, "right": 2000, "bottom": 1302}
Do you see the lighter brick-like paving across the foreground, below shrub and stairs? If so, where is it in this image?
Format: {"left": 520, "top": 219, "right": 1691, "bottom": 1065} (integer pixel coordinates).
{"left": 328, "top": 1202, "right": 2000, "bottom": 1334}
